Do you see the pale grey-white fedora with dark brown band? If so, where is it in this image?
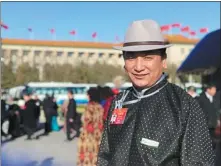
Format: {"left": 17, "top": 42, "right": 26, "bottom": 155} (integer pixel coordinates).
{"left": 113, "top": 20, "right": 171, "bottom": 52}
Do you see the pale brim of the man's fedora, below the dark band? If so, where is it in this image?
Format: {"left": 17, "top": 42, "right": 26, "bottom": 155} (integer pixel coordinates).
{"left": 113, "top": 44, "right": 172, "bottom": 52}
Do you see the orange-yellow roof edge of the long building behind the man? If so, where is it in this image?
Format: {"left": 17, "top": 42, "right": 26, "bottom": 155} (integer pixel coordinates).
{"left": 2, "top": 35, "right": 199, "bottom": 49}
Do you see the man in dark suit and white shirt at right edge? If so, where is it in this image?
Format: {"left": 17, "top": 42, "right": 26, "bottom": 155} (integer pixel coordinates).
{"left": 198, "top": 84, "right": 220, "bottom": 148}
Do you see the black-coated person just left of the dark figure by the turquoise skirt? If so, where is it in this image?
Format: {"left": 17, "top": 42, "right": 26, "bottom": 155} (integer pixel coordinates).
{"left": 22, "top": 92, "right": 38, "bottom": 140}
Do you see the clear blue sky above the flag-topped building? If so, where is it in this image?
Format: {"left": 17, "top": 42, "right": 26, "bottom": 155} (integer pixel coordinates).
{"left": 1, "top": 2, "right": 220, "bottom": 42}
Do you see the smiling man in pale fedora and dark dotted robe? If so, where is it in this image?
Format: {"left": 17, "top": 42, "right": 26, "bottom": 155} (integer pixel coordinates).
{"left": 97, "top": 20, "right": 215, "bottom": 166}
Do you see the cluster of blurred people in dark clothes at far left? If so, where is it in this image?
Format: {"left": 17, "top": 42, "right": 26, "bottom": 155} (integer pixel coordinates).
{"left": 1, "top": 91, "right": 58, "bottom": 140}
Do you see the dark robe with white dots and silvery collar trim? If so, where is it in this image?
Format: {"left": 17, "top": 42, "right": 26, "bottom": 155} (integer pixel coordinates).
{"left": 97, "top": 75, "right": 215, "bottom": 166}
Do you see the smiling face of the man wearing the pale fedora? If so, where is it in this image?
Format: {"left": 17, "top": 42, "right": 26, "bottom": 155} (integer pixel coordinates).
{"left": 124, "top": 51, "right": 166, "bottom": 88}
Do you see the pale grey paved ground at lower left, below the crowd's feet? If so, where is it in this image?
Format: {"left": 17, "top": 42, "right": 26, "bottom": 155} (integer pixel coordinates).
{"left": 1, "top": 125, "right": 78, "bottom": 166}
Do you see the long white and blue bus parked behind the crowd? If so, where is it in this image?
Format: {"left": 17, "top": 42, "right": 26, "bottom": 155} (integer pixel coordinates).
{"left": 8, "top": 82, "right": 97, "bottom": 105}
